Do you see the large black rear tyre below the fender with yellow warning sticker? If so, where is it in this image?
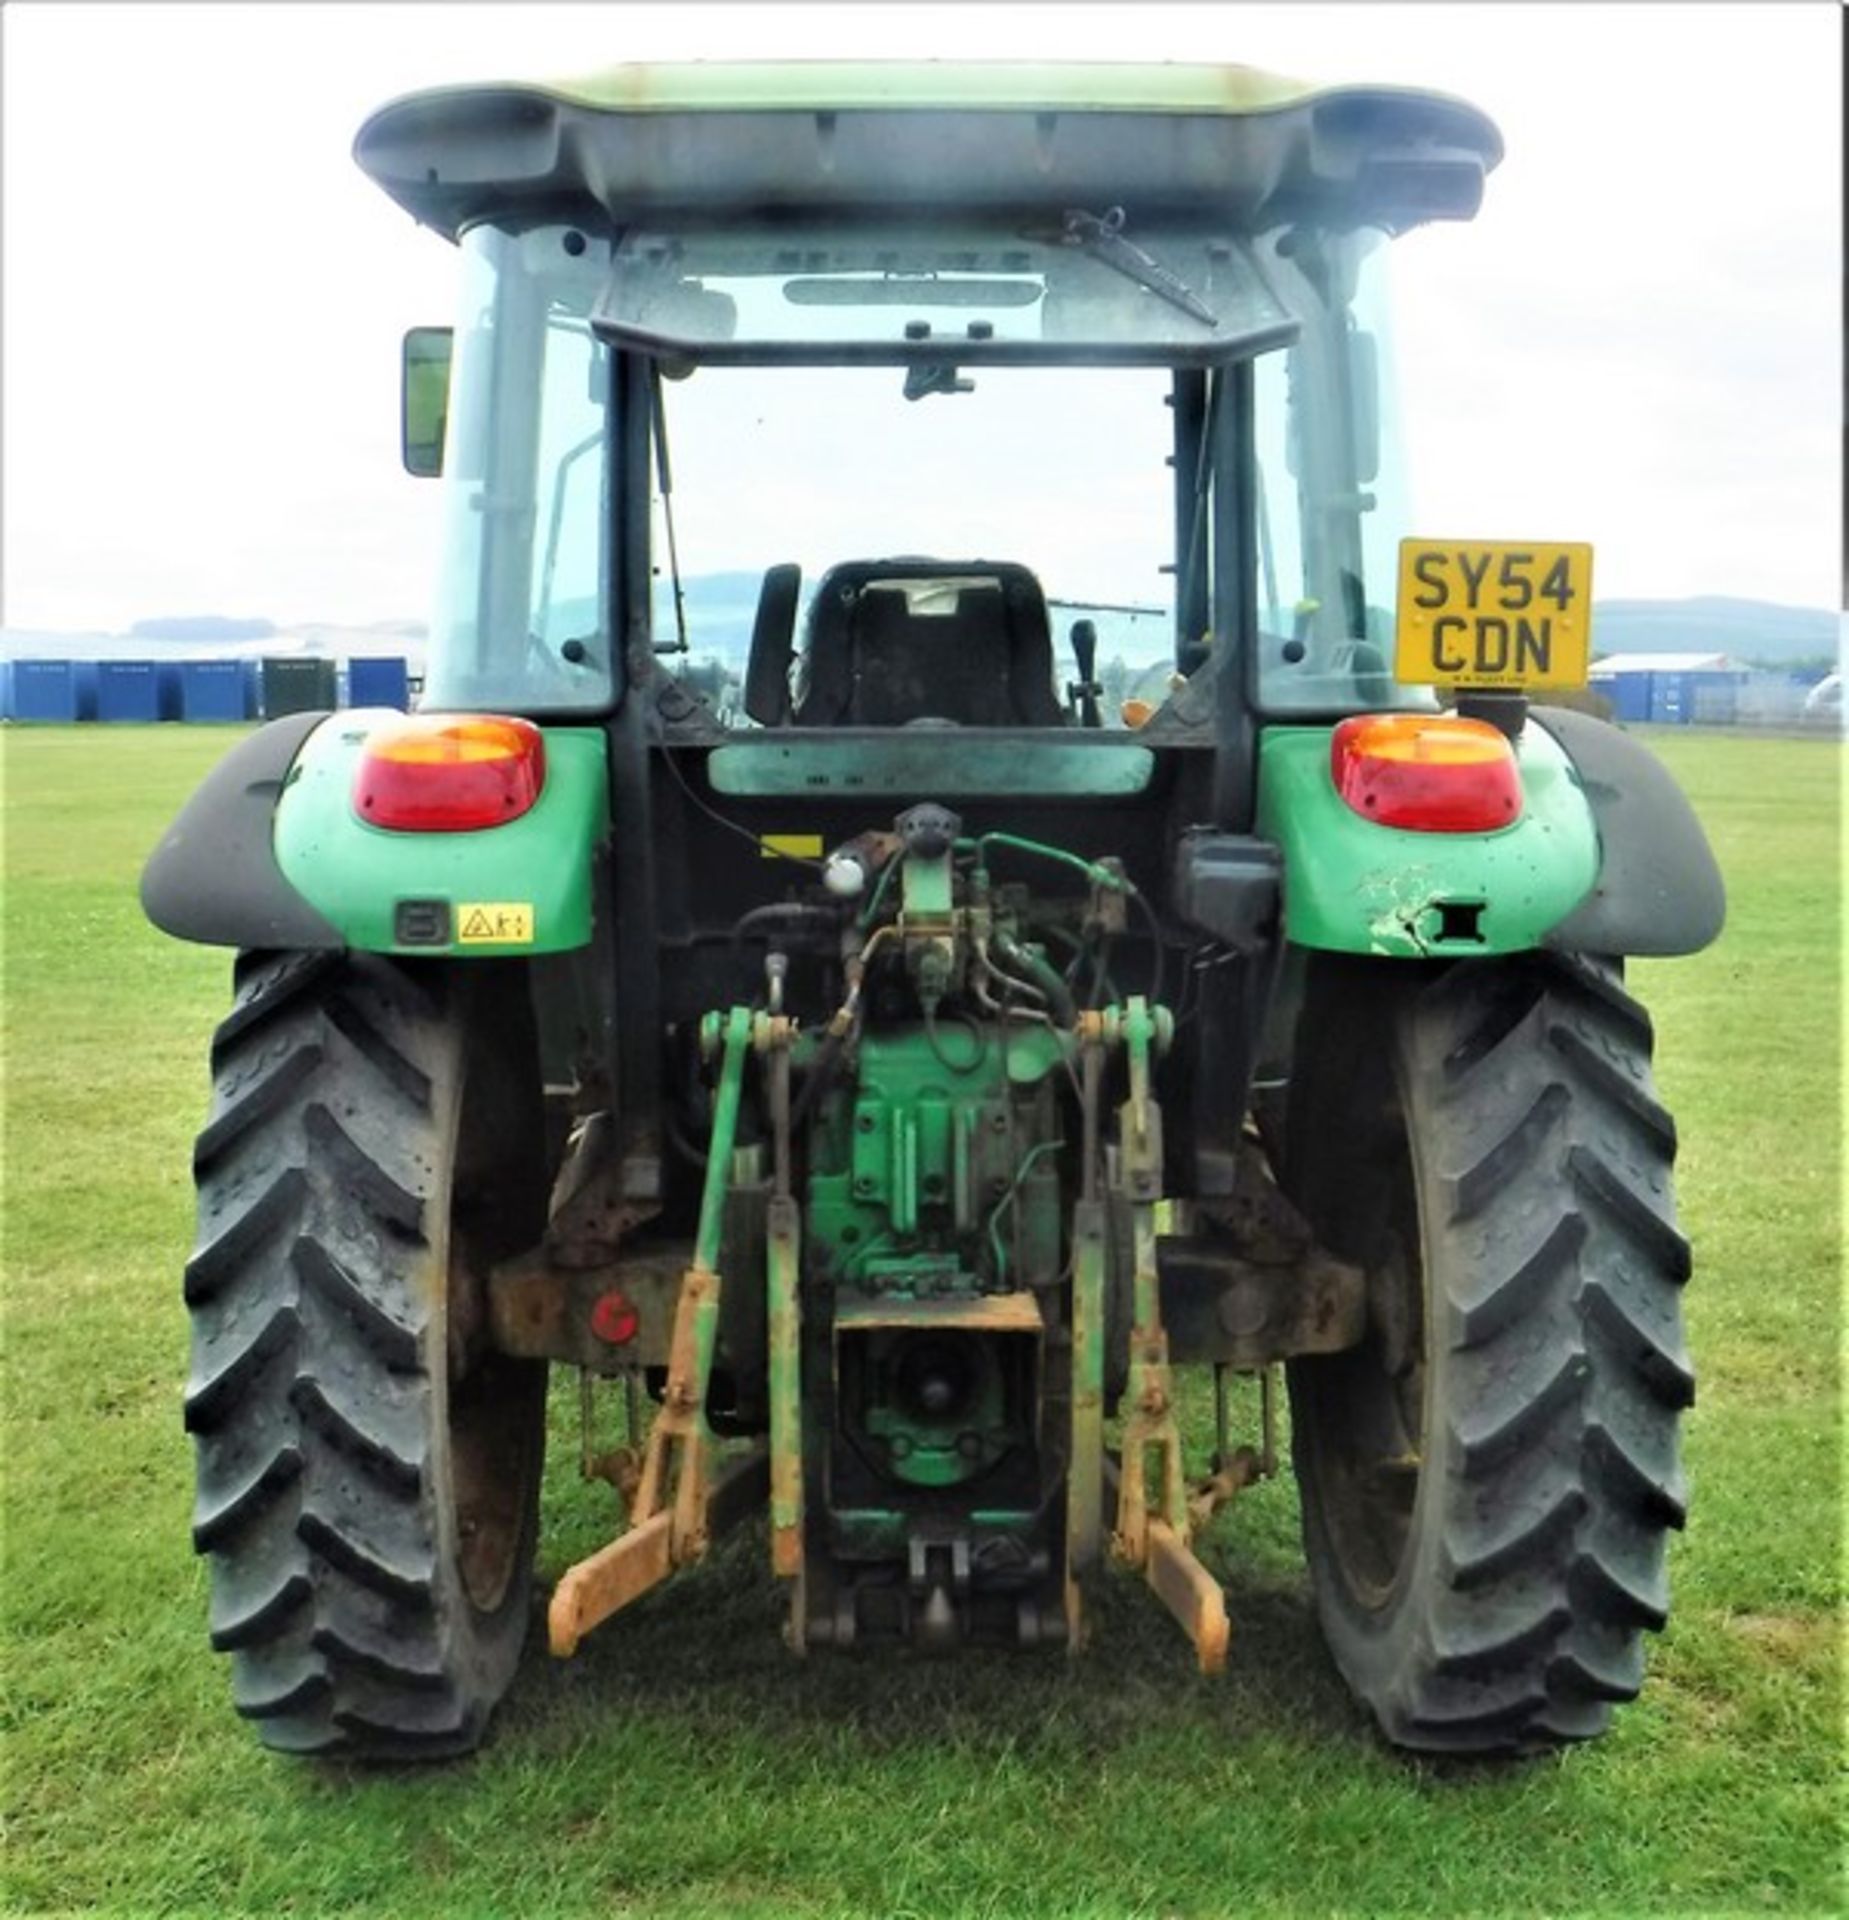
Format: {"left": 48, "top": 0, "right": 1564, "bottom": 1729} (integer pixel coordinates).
{"left": 186, "top": 952, "right": 545, "bottom": 1759}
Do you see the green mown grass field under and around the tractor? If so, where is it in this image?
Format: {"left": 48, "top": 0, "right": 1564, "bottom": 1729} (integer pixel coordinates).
{"left": 0, "top": 726, "right": 1845, "bottom": 1920}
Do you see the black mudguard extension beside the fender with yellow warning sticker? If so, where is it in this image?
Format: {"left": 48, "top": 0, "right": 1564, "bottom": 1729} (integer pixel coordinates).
{"left": 142, "top": 712, "right": 346, "bottom": 948}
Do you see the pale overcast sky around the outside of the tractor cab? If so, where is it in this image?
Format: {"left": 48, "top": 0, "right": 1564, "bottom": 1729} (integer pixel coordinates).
{"left": 0, "top": 0, "right": 1843, "bottom": 630}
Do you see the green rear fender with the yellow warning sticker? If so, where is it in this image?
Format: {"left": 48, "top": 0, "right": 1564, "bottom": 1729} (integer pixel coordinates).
{"left": 275, "top": 708, "right": 609, "bottom": 958}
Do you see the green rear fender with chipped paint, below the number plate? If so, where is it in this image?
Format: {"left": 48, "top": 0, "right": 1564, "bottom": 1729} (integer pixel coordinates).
{"left": 1258, "top": 726, "right": 1599, "bottom": 958}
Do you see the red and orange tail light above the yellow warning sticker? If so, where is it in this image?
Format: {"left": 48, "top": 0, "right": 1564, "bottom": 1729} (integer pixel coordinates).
{"left": 353, "top": 714, "right": 545, "bottom": 833}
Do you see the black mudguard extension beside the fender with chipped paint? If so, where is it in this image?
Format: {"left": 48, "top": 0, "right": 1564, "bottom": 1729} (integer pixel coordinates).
{"left": 1530, "top": 707, "right": 1726, "bottom": 954}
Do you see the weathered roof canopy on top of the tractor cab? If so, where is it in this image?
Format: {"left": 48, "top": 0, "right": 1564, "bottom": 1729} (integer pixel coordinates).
{"left": 353, "top": 61, "right": 1501, "bottom": 240}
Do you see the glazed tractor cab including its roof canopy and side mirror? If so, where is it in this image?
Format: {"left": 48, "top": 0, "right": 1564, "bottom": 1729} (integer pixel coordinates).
{"left": 372, "top": 65, "right": 1500, "bottom": 748}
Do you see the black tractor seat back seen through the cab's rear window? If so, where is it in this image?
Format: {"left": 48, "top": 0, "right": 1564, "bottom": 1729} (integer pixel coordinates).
{"left": 791, "top": 559, "right": 1066, "bottom": 726}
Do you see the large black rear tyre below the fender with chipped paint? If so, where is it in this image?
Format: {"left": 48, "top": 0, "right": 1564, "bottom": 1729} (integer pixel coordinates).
{"left": 1285, "top": 954, "right": 1693, "bottom": 1755}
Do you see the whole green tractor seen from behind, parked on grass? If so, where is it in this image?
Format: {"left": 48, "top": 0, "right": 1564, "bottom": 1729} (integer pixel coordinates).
{"left": 142, "top": 63, "right": 1722, "bottom": 1757}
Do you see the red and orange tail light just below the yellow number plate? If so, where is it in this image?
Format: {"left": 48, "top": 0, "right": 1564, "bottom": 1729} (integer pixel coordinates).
{"left": 1329, "top": 714, "right": 1521, "bottom": 833}
